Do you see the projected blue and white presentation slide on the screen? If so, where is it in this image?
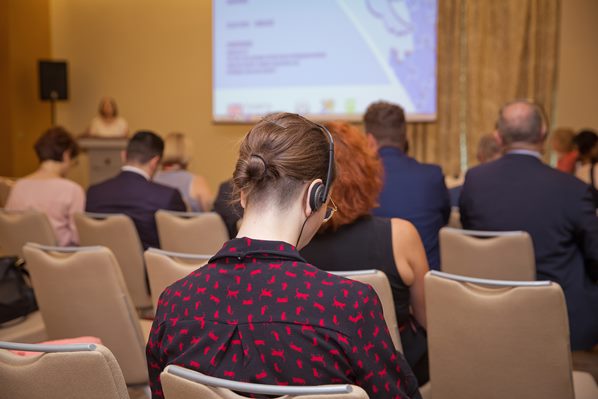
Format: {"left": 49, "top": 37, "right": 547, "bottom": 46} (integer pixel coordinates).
{"left": 212, "top": 0, "right": 437, "bottom": 122}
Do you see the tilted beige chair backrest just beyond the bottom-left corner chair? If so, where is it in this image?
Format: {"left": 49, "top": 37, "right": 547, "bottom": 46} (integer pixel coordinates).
{"left": 23, "top": 244, "right": 148, "bottom": 384}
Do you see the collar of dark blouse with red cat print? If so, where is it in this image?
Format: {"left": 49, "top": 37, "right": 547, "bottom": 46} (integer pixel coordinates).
{"left": 210, "top": 237, "right": 307, "bottom": 263}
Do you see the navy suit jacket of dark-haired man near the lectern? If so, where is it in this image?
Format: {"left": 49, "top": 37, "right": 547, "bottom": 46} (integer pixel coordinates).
{"left": 85, "top": 171, "right": 186, "bottom": 249}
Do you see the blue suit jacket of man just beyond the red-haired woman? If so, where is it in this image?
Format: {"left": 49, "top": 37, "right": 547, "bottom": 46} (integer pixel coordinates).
{"left": 374, "top": 147, "right": 451, "bottom": 270}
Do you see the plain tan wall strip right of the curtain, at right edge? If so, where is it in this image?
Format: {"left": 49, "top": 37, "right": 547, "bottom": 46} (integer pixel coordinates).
{"left": 556, "top": 0, "right": 598, "bottom": 130}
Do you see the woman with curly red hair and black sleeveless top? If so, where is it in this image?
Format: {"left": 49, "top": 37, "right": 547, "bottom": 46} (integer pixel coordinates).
{"left": 301, "top": 123, "right": 429, "bottom": 386}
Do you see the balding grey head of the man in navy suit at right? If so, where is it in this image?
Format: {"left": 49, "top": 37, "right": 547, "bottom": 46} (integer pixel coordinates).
{"left": 496, "top": 100, "right": 545, "bottom": 146}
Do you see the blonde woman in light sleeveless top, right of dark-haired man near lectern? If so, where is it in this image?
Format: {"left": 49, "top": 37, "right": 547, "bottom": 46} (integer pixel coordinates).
{"left": 154, "top": 133, "right": 212, "bottom": 212}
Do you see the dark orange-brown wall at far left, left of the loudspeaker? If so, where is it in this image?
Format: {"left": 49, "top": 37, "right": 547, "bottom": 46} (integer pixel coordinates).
{"left": 0, "top": 0, "right": 51, "bottom": 176}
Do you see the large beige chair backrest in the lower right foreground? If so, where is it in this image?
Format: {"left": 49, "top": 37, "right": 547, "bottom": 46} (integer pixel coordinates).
{"left": 425, "top": 271, "right": 574, "bottom": 399}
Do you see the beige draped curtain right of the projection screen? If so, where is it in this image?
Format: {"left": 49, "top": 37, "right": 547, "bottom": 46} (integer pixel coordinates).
{"left": 408, "top": 0, "right": 560, "bottom": 176}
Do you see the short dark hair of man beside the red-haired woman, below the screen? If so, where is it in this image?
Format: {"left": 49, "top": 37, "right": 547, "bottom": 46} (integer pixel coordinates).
{"left": 363, "top": 101, "right": 407, "bottom": 148}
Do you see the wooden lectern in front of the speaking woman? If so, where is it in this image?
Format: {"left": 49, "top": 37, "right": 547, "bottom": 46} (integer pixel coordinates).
{"left": 78, "top": 136, "right": 128, "bottom": 185}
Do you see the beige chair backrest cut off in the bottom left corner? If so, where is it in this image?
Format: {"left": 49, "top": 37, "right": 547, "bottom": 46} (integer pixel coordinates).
{"left": 0, "top": 342, "right": 129, "bottom": 399}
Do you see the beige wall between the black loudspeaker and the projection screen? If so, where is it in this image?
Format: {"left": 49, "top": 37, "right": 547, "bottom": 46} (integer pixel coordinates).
{"left": 51, "top": 0, "right": 248, "bottom": 189}
